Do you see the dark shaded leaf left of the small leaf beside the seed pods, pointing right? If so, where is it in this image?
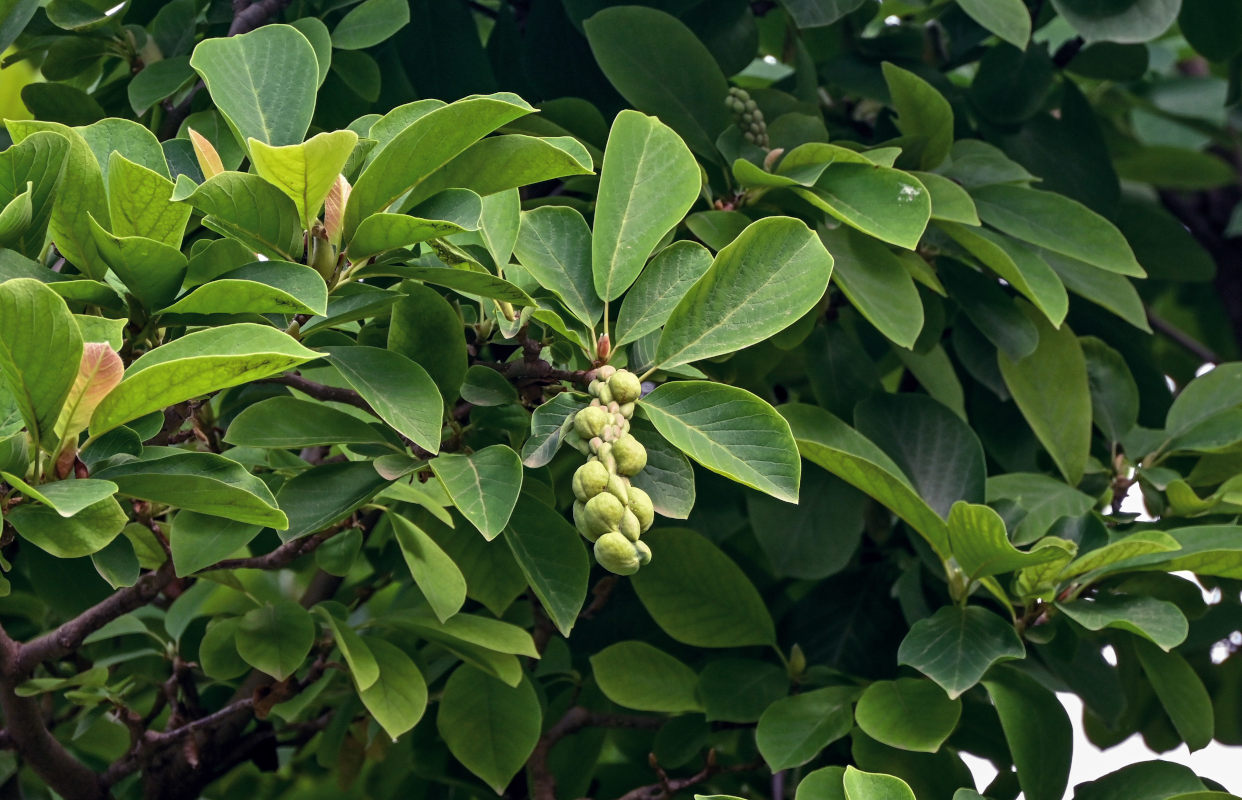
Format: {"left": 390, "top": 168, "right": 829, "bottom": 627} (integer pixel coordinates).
{"left": 276, "top": 461, "right": 391, "bottom": 542}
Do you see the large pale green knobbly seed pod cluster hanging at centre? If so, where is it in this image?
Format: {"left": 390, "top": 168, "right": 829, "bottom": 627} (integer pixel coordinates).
{"left": 574, "top": 366, "right": 656, "bottom": 575}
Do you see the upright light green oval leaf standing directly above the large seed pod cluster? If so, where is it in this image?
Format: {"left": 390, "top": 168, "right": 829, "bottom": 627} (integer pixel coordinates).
{"left": 591, "top": 109, "right": 700, "bottom": 301}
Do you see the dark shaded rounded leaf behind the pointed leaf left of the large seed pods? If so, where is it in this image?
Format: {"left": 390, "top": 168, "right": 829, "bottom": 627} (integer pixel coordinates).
{"left": 388, "top": 283, "right": 468, "bottom": 400}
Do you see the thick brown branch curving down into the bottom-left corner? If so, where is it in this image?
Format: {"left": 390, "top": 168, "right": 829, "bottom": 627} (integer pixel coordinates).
{"left": 0, "top": 627, "right": 108, "bottom": 800}
